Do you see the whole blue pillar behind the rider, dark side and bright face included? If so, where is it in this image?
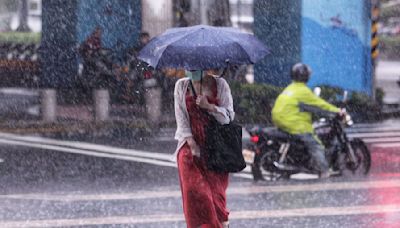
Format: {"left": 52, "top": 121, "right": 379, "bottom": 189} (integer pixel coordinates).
{"left": 254, "top": 0, "right": 372, "bottom": 94}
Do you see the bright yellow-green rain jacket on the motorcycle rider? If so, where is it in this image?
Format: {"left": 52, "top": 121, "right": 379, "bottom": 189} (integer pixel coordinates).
{"left": 272, "top": 82, "right": 340, "bottom": 134}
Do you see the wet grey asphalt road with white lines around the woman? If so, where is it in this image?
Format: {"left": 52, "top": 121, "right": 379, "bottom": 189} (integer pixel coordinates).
{"left": 0, "top": 121, "right": 400, "bottom": 227}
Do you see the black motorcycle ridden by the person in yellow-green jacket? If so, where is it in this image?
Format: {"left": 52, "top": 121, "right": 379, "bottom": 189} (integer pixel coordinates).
{"left": 243, "top": 88, "right": 371, "bottom": 181}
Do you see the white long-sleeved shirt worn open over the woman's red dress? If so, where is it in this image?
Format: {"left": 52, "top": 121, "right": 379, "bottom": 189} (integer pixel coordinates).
{"left": 173, "top": 78, "right": 235, "bottom": 161}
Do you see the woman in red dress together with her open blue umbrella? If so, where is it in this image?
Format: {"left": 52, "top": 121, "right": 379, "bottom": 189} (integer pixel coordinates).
{"left": 139, "top": 25, "right": 268, "bottom": 228}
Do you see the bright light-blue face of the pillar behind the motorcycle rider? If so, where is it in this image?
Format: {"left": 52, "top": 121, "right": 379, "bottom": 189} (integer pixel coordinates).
{"left": 301, "top": 0, "right": 372, "bottom": 94}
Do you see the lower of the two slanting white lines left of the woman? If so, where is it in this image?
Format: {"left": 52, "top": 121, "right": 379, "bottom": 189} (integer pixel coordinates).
{"left": 0, "top": 139, "right": 176, "bottom": 167}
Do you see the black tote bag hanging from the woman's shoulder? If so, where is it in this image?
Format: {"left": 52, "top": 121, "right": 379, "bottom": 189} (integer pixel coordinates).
{"left": 190, "top": 81, "right": 246, "bottom": 173}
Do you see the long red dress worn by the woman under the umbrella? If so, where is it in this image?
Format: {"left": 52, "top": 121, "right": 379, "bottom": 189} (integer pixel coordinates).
{"left": 178, "top": 83, "right": 229, "bottom": 228}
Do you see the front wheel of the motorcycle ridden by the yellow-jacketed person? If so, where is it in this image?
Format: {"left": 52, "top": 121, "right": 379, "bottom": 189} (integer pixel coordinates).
{"left": 337, "top": 139, "right": 371, "bottom": 176}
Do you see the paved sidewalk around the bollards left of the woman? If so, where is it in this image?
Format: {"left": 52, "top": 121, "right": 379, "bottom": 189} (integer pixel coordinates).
{"left": 0, "top": 104, "right": 175, "bottom": 141}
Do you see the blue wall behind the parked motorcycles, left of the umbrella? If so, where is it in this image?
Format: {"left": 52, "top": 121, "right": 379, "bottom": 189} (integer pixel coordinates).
{"left": 41, "top": 0, "right": 141, "bottom": 87}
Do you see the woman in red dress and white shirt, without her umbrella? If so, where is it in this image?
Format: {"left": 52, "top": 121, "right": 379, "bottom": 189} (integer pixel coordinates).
{"left": 174, "top": 70, "right": 235, "bottom": 227}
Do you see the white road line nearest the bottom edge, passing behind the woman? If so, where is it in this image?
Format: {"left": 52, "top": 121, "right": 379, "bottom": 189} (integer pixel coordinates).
{"left": 0, "top": 204, "right": 400, "bottom": 228}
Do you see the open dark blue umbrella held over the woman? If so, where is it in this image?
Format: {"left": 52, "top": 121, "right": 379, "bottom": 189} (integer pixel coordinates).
{"left": 139, "top": 25, "right": 268, "bottom": 70}
